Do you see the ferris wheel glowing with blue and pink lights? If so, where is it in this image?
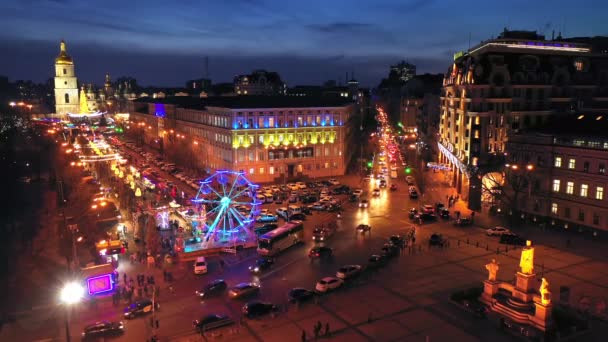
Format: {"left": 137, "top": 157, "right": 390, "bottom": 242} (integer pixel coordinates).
{"left": 192, "top": 170, "right": 262, "bottom": 246}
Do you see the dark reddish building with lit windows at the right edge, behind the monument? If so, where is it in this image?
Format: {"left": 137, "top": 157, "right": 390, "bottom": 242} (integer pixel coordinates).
{"left": 507, "top": 114, "right": 608, "bottom": 231}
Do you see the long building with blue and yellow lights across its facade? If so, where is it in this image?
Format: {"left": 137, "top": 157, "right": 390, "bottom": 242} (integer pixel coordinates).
{"left": 130, "top": 96, "right": 353, "bottom": 183}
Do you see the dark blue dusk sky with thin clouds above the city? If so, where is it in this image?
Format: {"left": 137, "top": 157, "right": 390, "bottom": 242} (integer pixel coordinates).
{"left": 0, "top": 0, "right": 608, "bottom": 86}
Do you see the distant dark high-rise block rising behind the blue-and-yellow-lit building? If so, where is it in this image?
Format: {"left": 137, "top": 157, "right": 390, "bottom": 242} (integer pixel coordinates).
{"left": 234, "top": 70, "right": 287, "bottom": 95}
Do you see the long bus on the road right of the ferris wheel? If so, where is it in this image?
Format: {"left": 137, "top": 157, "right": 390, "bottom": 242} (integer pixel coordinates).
{"left": 258, "top": 221, "right": 304, "bottom": 256}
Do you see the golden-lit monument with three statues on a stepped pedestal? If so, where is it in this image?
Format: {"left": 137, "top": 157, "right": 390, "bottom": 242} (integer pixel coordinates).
{"left": 480, "top": 240, "right": 553, "bottom": 331}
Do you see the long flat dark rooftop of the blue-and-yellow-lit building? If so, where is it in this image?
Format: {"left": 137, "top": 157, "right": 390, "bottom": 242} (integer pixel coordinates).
{"left": 136, "top": 96, "right": 352, "bottom": 109}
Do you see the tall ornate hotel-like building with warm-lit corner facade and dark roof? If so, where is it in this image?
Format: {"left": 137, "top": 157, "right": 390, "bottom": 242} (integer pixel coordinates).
{"left": 438, "top": 30, "right": 608, "bottom": 210}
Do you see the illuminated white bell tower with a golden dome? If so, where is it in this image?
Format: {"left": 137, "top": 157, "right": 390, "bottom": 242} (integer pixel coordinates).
{"left": 55, "top": 40, "right": 80, "bottom": 114}
